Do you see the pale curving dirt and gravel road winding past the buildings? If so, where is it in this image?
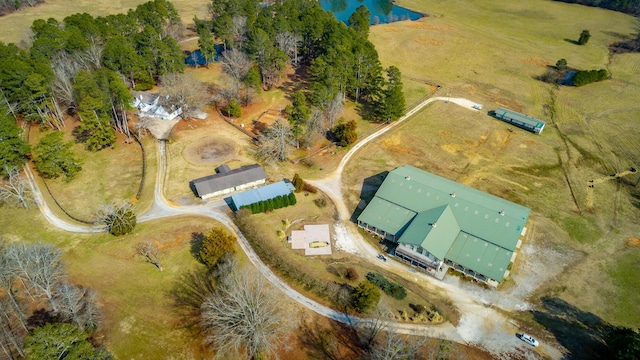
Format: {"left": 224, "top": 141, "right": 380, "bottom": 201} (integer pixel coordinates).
{"left": 25, "top": 97, "right": 562, "bottom": 359}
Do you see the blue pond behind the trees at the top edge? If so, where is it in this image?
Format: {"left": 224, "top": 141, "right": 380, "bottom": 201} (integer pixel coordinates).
{"left": 320, "top": 0, "right": 424, "bottom": 25}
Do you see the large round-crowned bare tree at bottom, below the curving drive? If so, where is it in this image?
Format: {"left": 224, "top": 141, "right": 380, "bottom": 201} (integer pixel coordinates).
{"left": 201, "top": 271, "right": 296, "bottom": 358}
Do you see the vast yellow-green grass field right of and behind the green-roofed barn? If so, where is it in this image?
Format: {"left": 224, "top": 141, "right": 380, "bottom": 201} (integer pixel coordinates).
{"left": 364, "top": 0, "right": 640, "bottom": 327}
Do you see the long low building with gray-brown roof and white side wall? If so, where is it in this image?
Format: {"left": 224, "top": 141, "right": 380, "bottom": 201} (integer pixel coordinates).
{"left": 189, "top": 164, "right": 267, "bottom": 200}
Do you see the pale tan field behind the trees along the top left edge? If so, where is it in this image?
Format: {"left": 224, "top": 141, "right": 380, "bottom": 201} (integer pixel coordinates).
{"left": 0, "top": 0, "right": 209, "bottom": 43}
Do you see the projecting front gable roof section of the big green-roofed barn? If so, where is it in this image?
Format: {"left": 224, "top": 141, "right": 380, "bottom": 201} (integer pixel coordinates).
{"left": 398, "top": 205, "right": 460, "bottom": 259}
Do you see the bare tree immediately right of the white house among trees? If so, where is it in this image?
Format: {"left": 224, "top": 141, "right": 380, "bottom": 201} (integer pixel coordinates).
{"left": 160, "top": 73, "right": 208, "bottom": 118}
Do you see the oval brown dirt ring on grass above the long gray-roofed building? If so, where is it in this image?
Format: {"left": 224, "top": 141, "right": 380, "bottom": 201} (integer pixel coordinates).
{"left": 182, "top": 137, "right": 236, "bottom": 165}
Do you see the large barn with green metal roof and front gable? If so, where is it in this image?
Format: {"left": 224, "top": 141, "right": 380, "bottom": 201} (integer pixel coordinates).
{"left": 358, "top": 166, "right": 531, "bottom": 287}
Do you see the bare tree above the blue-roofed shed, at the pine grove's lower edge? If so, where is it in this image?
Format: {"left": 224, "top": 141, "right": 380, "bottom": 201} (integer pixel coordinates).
{"left": 257, "top": 118, "right": 297, "bottom": 162}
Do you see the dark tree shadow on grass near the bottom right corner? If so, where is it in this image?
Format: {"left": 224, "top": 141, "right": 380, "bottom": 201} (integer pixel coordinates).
{"left": 532, "top": 297, "right": 614, "bottom": 359}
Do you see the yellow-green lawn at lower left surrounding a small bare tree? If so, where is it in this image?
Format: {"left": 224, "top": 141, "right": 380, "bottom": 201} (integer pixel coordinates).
{"left": 65, "top": 217, "right": 216, "bottom": 359}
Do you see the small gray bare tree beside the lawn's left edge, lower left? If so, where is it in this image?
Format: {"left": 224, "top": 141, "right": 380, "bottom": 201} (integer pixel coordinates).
{"left": 55, "top": 282, "right": 102, "bottom": 333}
